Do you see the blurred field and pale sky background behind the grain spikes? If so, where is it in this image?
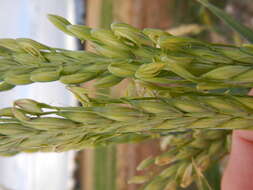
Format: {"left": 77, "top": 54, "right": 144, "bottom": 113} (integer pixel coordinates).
{"left": 0, "top": 0, "right": 253, "bottom": 190}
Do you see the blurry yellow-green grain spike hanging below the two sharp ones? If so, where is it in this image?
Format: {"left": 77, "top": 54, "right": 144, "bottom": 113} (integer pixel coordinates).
{"left": 129, "top": 130, "right": 231, "bottom": 190}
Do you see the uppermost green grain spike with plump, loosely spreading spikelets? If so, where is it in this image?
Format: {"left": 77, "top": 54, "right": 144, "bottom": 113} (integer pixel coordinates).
{"left": 0, "top": 15, "right": 253, "bottom": 90}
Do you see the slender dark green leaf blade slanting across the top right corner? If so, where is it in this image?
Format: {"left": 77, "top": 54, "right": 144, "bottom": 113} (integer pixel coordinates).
{"left": 197, "top": 0, "right": 253, "bottom": 43}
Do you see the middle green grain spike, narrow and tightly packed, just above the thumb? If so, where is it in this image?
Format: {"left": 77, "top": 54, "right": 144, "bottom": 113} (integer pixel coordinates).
{"left": 0, "top": 90, "right": 250, "bottom": 157}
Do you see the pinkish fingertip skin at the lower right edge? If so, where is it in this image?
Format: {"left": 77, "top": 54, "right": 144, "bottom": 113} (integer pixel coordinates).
{"left": 221, "top": 90, "right": 253, "bottom": 190}
